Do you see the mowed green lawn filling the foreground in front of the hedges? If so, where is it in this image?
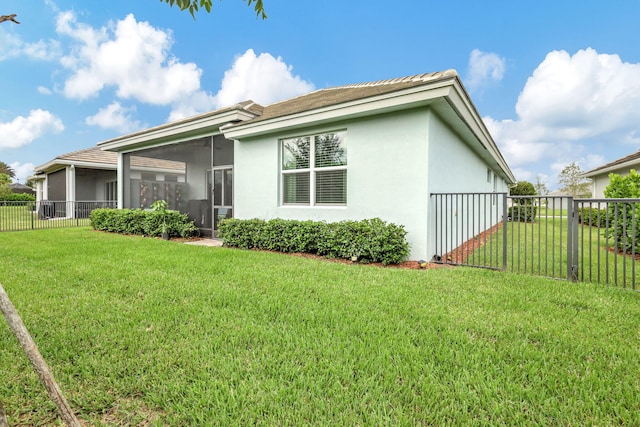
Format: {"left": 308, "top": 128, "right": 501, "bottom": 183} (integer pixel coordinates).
{"left": 0, "top": 228, "right": 640, "bottom": 426}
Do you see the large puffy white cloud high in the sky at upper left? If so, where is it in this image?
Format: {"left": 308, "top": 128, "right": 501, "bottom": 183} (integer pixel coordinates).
{"left": 57, "top": 11, "right": 202, "bottom": 105}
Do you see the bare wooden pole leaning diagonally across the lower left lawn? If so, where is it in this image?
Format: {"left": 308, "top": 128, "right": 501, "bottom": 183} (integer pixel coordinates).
{"left": 0, "top": 283, "right": 80, "bottom": 427}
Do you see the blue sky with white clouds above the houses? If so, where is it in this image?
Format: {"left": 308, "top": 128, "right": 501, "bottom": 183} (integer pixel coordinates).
{"left": 0, "top": 0, "right": 640, "bottom": 189}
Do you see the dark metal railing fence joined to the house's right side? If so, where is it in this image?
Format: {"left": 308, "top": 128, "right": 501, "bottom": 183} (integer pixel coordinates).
{"left": 431, "top": 193, "right": 640, "bottom": 289}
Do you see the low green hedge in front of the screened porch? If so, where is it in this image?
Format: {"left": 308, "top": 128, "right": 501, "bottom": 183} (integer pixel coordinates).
{"left": 89, "top": 208, "right": 200, "bottom": 238}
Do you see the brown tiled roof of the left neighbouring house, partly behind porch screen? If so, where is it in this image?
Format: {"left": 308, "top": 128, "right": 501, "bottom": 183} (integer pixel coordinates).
{"left": 34, "top": 147, "right": 185, "bottom": 173}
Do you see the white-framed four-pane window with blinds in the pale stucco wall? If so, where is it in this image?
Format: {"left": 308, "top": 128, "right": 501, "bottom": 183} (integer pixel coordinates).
{"left": 281, "top": 132, "right": 347, "bottom": 206}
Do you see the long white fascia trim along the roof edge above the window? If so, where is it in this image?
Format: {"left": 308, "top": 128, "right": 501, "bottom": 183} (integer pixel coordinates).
{"left": 223, "top": 79, "right": 452, "bottom": 139}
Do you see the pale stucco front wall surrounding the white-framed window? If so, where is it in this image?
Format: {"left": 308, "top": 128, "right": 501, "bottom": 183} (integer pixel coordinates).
{"left": 234, "top": 109, "right": 429, "bottom": 258}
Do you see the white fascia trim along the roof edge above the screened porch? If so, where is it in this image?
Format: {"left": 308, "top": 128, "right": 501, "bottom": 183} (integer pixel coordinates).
{"left": 97, "top": 111, "right": 255, "bottom": 151}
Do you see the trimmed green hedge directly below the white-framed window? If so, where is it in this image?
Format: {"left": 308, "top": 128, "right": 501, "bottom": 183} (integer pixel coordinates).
{"left": 218, "top": 218, "right": 409, "bottom": 265}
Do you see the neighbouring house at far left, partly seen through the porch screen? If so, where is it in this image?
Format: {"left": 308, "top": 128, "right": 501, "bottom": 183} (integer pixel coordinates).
{"left": 29, "top": 147, "right": 185, "bottom": 212}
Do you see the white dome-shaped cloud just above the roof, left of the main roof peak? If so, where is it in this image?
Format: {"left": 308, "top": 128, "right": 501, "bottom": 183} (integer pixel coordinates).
{"left": 215, "top": 49, "right": 314, "bottom": 107}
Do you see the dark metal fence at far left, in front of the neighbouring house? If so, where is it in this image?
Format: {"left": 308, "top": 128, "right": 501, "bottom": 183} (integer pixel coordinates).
{"left": 0, "top": 200, "right": 116, "bottom": 231}
